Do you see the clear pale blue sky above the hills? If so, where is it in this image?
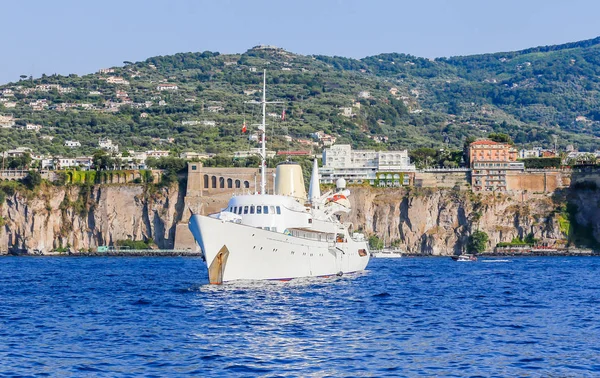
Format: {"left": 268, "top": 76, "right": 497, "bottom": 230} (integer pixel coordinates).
{"left": 0, "top": 0, "right": 600, "bottom": 83}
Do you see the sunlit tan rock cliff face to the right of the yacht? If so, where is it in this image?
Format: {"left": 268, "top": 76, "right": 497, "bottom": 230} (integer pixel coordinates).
{"left": 348, "top": 188, "right": 567, "bottom": 255}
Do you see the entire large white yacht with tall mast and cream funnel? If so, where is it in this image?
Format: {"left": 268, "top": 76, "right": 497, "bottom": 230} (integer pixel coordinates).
{"left": 189, "top": 71, "right": 370, "bottom": 284}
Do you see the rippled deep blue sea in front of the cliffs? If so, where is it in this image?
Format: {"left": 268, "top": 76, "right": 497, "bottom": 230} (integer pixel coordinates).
{"left": 0, "top": 257, "right": 600, "bottom": 377}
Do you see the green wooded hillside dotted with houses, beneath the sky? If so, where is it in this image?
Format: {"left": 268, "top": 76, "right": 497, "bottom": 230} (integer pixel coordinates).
{"left": 0, "top": 38, "right": 600, "bottom": 155}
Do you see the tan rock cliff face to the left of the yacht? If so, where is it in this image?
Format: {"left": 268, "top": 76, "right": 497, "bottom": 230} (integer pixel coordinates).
{"left": 0, "top": 185, "right": 183, "bottom": 252}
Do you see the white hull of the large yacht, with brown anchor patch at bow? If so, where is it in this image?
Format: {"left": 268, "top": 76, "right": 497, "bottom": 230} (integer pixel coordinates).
{"left": 189, "top": 214, "right": 369, "bottom": 284}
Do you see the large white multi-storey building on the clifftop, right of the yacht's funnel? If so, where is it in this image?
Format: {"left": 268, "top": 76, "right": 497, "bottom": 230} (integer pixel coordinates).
{"left": 319, "top": 144, "right": 415, "bottom": 185}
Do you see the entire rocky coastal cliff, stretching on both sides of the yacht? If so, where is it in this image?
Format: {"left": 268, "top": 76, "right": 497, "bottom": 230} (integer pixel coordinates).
{"left": 0, "top": 179, "right": 600, "bottom": 255}
